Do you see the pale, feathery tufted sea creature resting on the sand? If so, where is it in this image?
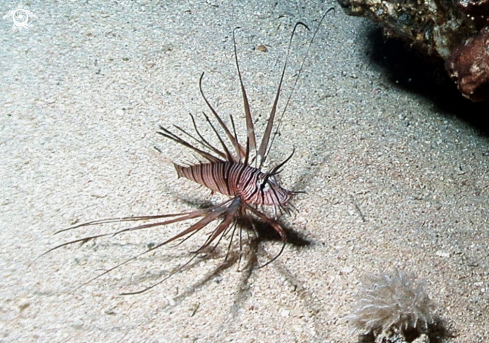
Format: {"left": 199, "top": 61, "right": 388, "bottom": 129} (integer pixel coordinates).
{"left": 346, "top": 269, "right": 435, "bottom": 337}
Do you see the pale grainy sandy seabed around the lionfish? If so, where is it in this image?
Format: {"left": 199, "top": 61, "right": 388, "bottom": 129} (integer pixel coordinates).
{"left": 0, "top": 0, "right": 489, "bottom": 343}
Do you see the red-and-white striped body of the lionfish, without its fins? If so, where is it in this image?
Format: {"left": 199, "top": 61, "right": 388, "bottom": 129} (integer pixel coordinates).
{"left": 175, "top": 161, "right": 292, "bottom": 206}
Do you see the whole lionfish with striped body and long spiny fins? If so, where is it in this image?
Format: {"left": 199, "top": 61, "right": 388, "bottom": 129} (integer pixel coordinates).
{"left": 41, "top": 11, "right": 329, "bottom": 294}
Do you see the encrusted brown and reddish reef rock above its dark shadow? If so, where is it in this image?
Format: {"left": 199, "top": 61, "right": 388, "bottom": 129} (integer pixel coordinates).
{"left": 338, "top": 0, "right": 489, "bottom": 101}
